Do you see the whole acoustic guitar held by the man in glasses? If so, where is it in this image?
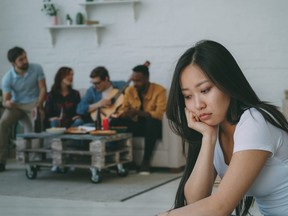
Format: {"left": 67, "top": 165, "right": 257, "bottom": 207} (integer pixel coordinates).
{"left": 91, "top": 79, "right": 131, "bottom": 121}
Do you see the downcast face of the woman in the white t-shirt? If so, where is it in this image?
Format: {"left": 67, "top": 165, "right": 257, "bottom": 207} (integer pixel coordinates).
{"left": 180, "top": 64, "right": 230, "bottom": 126}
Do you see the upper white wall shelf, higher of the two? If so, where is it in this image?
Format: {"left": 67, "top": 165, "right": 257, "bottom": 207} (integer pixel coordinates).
{"left": 79, "top": 0, "right": 140, "bottom": 21}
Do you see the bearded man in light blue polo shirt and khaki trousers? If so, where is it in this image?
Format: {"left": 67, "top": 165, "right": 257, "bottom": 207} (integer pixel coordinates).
{"left": 0, "top": 47, "right": 46, "bottom": 172}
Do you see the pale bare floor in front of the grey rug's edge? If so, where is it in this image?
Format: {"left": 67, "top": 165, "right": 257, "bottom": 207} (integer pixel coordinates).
{"left": 0, "top": 177, "right": 260, "bottom": 216}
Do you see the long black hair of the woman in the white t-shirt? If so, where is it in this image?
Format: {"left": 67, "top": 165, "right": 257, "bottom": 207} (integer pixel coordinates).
{"left": 166, "top": 40, "right": 288, "bottom": 215}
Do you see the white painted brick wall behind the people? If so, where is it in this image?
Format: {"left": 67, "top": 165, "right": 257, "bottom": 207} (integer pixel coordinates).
{"left": 0, "top": 0, "right": 288, "bottom": 106}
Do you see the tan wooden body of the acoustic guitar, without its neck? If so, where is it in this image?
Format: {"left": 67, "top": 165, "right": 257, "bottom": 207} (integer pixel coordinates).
{"left": 91, "top": 88, "right": 124, "bottom": 121}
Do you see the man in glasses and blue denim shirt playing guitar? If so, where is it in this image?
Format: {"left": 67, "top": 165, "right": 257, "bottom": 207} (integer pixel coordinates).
{"left": 77, "top": 66, "right": 126, "bottom": 123}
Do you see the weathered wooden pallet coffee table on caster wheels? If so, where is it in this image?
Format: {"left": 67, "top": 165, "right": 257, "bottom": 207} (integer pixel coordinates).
{"left": 16, "top": 132, "right": 132, "bottom": 183}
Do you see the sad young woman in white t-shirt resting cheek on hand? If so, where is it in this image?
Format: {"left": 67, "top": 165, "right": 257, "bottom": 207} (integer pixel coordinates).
{"left": 159, "top": 40, "right": 288, "bottom": 216}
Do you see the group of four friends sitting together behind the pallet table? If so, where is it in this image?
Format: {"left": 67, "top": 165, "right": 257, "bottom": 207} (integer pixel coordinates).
{"left": 0, "top": 47, "right": 166, "bottom": 174}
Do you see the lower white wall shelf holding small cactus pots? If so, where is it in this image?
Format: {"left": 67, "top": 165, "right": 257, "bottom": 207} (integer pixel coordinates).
{"left": 46, "top": 24, "right": 104, "bottom": 46}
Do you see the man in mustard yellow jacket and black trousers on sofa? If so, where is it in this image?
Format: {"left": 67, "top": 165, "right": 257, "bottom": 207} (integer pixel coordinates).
{"left": 110, "top": 61, "right": 166, "bottom": 174}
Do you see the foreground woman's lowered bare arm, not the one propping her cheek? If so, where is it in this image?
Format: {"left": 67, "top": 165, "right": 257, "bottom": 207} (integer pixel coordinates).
{"left": 159, "top": 150, "right": 271, "bottom": 216}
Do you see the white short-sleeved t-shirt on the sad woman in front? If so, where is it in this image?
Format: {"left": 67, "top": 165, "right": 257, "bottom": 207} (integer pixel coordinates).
{"left": 214, "top": 108, "right": 288, "bottom": 216}
